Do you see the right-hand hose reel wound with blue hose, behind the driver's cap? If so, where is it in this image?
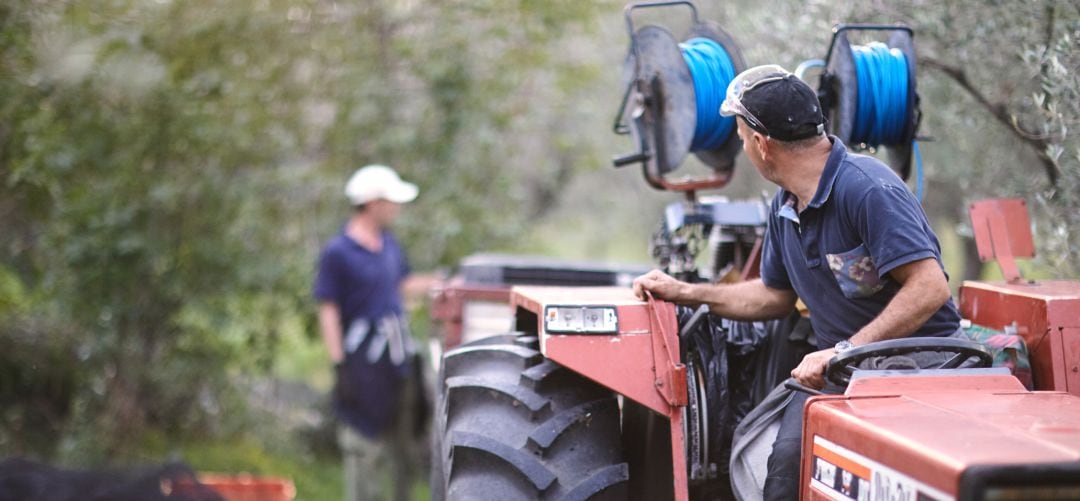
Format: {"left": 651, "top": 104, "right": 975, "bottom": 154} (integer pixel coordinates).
{"left": 796, "top": 24, "right": 921, "bottom": 182}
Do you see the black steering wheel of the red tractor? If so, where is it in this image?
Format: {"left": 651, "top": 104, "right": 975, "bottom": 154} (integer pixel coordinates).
{"left": 825, "top": 338, "right": 994, "bottom": 387}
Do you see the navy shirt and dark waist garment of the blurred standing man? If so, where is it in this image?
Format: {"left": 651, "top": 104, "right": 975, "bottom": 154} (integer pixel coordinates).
{"left": 313, "top": 231, "right": 414, "bottom": 437}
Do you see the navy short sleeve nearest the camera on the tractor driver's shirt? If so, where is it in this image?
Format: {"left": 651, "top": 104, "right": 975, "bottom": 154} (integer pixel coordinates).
{"left": 855, "top": 185, "right": 941, "bottom": 279}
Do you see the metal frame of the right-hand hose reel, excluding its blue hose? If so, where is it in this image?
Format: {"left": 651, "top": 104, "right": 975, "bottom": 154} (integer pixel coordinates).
{"left": 812, "top": 24, "right": 922, "bottom": 180}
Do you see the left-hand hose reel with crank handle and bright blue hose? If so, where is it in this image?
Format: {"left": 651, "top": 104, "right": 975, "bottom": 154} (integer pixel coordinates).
{"left": 612, "top": 1, "right": 746, "bottom": 191}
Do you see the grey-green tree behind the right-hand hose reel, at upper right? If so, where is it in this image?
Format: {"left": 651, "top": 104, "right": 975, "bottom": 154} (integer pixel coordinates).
{"left": 699, "top": 0, "right": 1080, "bottom": 283}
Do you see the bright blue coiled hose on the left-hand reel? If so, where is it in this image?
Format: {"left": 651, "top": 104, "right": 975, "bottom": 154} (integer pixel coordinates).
{"left": 679, "top": 38, "right": 735, "bottom": 151}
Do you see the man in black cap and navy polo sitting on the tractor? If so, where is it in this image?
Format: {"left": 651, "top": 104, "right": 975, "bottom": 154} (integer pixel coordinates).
{"left": 634, "top": 65, "right": 962, "bottom": 500}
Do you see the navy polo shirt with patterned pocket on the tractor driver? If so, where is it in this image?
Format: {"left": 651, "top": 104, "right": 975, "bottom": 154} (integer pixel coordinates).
{"left": 761, "top": 136, "right": 960, "bottom": 349}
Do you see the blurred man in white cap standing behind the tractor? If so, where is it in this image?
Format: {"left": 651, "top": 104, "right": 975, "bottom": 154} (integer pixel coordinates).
{"left": 314, "top": 165, "right": 430, "bottom": 501}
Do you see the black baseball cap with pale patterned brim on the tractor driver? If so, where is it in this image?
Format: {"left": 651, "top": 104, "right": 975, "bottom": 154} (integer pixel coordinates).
{"left": 720, "top": 65, "right": 825, "bottom": 141}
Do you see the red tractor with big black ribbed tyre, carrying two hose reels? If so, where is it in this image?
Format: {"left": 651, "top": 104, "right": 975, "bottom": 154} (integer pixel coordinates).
{"left": 432, "top": 2, "right": 1080, "bottom": 500}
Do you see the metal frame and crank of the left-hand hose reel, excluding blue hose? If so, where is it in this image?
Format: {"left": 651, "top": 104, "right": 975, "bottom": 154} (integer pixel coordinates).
{"left": 612, "top": 1, "right": 746, "bottom": 192}
